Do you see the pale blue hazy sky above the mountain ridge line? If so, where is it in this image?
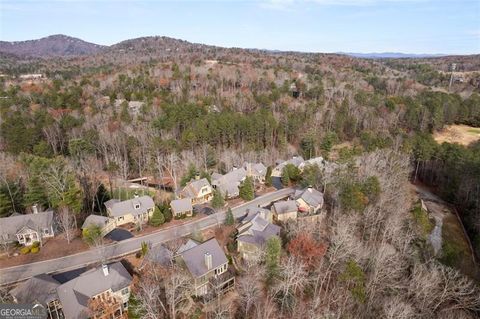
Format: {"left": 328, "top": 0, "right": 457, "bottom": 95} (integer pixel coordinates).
{"left": 0, "top": 0, "right": 480, "bottom": 54}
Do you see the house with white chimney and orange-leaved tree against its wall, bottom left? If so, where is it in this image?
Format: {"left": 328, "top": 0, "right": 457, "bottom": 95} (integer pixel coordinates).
{"left": 57, "top": 262, "right": 132, "bottom": 319}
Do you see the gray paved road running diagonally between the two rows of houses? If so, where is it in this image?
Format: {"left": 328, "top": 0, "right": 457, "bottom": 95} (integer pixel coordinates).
{"left": 0, "top": 188, "right": 293, "bottom": 285}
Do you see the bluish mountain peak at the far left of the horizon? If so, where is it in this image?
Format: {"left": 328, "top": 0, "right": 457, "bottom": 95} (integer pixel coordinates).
{"left": 0, "top": 34, "right": 104, "bottom": 57}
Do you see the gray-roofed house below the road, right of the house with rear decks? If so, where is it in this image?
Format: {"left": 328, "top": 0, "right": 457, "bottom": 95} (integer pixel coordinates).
{"left": 237, "top": 211, "right": 280, "bottom": 260}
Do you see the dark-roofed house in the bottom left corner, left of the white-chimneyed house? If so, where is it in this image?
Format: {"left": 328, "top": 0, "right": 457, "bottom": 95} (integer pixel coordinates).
{"left": 9, "top": 274, "right": 63, "bottom": 319}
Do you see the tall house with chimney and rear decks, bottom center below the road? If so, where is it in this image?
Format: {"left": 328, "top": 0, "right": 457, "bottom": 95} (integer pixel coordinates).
{"left": 179, "top": 238, "right": 235, "bottom": 297}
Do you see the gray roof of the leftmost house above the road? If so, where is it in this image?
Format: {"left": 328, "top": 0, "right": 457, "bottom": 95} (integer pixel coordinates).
{"left": 0, "top": 210, "right": 53, "bottom": 240}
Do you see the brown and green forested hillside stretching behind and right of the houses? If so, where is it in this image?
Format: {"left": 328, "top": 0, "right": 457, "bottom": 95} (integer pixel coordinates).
{"left": 0, "top": 37, "right": 480, "bottom": 318}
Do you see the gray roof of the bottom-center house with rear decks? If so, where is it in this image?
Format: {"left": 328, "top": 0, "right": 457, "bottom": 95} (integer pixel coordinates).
{"left": 180, "top": 238, "right": 228, "bottom": 278}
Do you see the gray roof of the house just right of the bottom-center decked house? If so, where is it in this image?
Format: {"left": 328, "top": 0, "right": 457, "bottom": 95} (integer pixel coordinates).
{"left": 237, "top": 213, "right": 280, "bottom": 246}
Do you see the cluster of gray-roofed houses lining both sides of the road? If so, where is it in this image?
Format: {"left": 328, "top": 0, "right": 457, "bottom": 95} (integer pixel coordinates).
{"left": 0, "top": 157, "right": 324, "bottom": 319}
